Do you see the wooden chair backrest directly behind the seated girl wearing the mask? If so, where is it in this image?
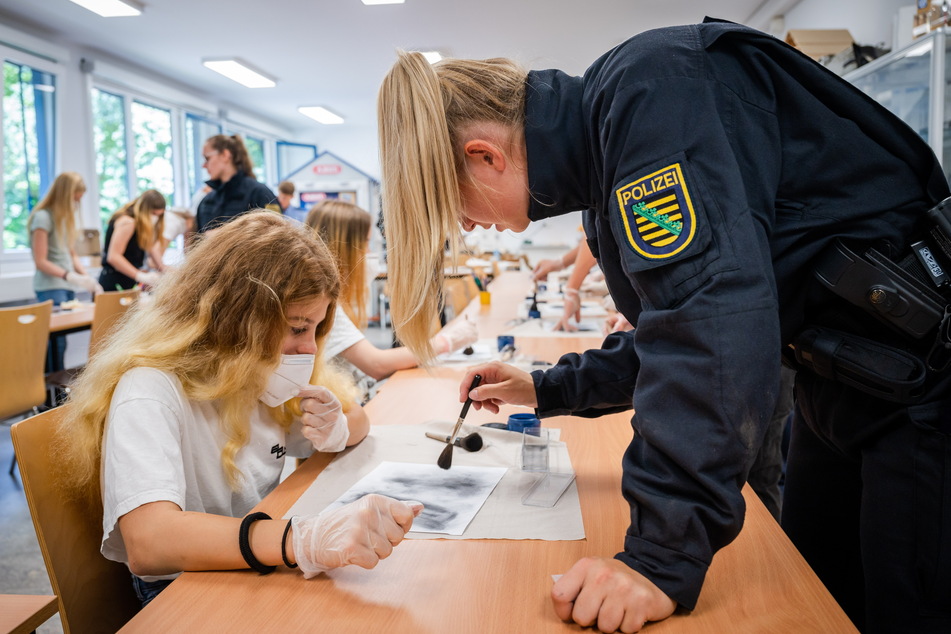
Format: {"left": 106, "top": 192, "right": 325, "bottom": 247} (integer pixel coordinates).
{"left": 10, "top": 405, "right": 141, "bottom": 634}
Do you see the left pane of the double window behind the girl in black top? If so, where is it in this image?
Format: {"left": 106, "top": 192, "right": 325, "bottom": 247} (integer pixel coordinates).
{"left": 92, "top": 88, "right": 130, "bottom": 227}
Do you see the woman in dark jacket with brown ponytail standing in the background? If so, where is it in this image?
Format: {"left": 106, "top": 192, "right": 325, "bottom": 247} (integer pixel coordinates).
{"left": 196, "top": 134, "right": 277, "bottom": 233}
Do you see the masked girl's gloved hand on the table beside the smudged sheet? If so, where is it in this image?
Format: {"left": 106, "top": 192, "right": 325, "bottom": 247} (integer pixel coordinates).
{"left": 291, "top": 493, "right": 423, "bottom": 579}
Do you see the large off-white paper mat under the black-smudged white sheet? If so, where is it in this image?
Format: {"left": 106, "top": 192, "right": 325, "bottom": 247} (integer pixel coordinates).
{"left": 284, "top": 421, "right": 584, "bottom": 541}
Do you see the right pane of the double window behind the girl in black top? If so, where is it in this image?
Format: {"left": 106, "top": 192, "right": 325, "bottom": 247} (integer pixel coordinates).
{"left": 132, "top": 101, "right": 175, "bottom": 201}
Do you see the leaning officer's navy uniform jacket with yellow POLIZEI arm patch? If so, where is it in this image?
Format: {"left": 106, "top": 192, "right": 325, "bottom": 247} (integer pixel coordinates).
{"left": 525, "top": 20, "right": 948, "bottom": 608}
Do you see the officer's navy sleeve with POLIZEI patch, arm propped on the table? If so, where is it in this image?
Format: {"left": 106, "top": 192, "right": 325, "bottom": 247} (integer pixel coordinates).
{"left": 600, "top": 70, "right": 780, "bottom": 609}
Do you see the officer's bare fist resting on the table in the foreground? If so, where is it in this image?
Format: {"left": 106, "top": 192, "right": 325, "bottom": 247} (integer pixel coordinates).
{"left": 551, "top": 557, "right": 677, "bottom": 633}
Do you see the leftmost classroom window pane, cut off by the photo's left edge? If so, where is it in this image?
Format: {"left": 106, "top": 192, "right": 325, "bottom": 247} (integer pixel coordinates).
{"left": 2, "top": 61, "right": 56, "bottom": 251}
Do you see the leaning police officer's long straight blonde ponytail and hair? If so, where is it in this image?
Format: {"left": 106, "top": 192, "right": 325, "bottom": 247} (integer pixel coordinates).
{"left": 378, "top": 52, "right": 526, "bottom": 364}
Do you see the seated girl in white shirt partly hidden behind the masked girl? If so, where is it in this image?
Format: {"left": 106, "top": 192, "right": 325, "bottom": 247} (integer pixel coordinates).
{"left": 307, "top": 200, "right": 478, "bottom": 398}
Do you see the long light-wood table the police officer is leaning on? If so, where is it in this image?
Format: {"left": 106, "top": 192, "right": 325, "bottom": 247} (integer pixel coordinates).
{"left": 122, "top": 274, "right": 855, "bottom": 634}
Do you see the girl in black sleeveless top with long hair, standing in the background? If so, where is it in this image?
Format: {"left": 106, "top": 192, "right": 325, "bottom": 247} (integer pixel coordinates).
{"left": 99, "top": 189, "right": 165, "bottom": 291}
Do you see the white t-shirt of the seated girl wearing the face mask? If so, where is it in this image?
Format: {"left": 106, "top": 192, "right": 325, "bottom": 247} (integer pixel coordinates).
{"left": 102, "top": 368, "right": 313, "bottom": 581}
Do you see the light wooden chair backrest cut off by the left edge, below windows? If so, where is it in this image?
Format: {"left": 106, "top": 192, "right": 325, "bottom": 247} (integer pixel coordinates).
{"left": 0, "top": 301, "right": 53, "bottom": 418}
